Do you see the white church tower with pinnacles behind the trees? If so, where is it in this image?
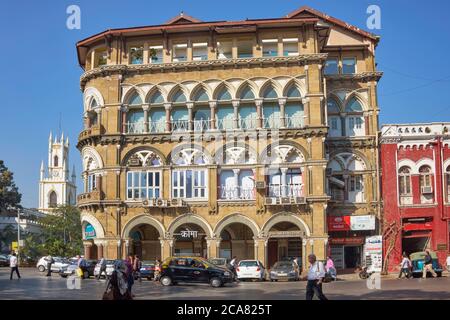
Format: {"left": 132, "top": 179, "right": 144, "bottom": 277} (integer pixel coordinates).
{"left": 39, "top": 133, "right": 77, "bottom": 213}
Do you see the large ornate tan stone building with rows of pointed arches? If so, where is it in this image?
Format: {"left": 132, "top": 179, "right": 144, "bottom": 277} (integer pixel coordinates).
{"left": 77, "top": 8, "right": 380, "bottom": 266}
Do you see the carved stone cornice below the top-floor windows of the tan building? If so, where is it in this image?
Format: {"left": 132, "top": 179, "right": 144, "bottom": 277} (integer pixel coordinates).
{"left": 80, "top": 53, "right": 328, "bottom": 89}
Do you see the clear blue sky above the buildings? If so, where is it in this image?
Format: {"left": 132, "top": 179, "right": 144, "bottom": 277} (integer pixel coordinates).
{"left": 0, "top": 0, "right": 450, "bottom": 207}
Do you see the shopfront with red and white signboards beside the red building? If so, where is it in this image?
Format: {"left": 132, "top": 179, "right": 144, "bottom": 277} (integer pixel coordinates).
{"left": 328, "top": 215, "right": 375, "bottom": 270}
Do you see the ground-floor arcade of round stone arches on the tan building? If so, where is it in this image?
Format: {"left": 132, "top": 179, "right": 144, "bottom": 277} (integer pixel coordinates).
{"left": 83, "top": 213, "right": 327, "bottom": 267}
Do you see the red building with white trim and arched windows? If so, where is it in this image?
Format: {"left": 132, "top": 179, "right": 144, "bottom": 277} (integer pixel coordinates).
{"left": 380, "top": 123, "right": 450, "bottom": 270}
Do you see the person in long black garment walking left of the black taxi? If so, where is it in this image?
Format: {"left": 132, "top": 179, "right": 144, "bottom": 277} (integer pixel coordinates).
{"left": 103, "top": 260, "right": 132, "bottom": 300}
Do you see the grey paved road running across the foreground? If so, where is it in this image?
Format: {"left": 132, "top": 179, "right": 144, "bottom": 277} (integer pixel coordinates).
{"left": 0, "top": 268, "right": 450, "bottom": 300}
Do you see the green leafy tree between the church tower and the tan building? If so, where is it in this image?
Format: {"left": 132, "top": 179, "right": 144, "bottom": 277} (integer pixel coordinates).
{"left": 39, "top": 205, "right": 83, "bottom": 256}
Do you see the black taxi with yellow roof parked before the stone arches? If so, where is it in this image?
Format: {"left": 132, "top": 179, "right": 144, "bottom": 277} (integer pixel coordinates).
{"left": 160, "top": 257, "right": 233, "bottom": 288}
